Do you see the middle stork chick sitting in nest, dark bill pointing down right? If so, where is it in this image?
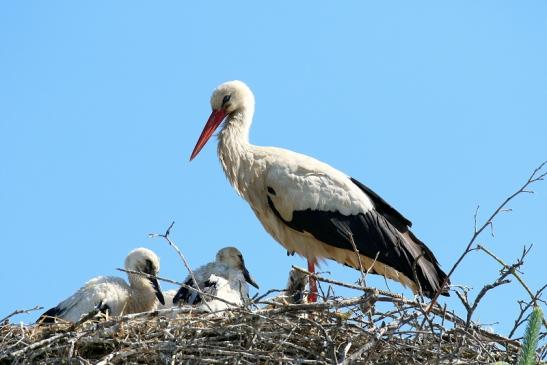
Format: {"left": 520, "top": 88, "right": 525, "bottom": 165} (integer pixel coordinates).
{"left": 173, "top": 247, "right": 258, "bottom": 311}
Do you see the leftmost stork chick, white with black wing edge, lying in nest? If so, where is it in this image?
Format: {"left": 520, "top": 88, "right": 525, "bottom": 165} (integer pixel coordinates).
{"left": 37, "top": 248, "right": 165, "bottom": 323}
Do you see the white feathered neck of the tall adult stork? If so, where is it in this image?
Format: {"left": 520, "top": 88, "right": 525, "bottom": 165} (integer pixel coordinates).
{"left": 217, "top": 107, "right": 254, "bottom": 195}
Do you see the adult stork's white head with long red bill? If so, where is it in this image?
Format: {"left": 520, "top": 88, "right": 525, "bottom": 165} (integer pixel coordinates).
{"left": 190, "top": 80, "right": 255, "bottom": 161}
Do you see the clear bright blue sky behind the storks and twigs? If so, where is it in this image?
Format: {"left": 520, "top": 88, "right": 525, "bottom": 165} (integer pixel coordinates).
{"left": 0, "top": 1, "right": 547, "bottom": 333}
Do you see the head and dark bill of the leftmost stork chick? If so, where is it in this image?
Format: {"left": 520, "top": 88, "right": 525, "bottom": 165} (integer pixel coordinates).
{"left": 125, "top": 247, "right": 165, "bottom": 304}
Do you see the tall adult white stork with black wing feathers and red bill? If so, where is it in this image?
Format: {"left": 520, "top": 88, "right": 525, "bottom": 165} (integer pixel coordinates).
{"left": 190, "top": 81, "right": 448, "bottom": 301}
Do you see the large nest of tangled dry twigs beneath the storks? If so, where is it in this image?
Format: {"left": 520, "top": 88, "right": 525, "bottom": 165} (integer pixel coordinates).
{"left": 0, "top": 293, "right": 519, "bottom": 364}
